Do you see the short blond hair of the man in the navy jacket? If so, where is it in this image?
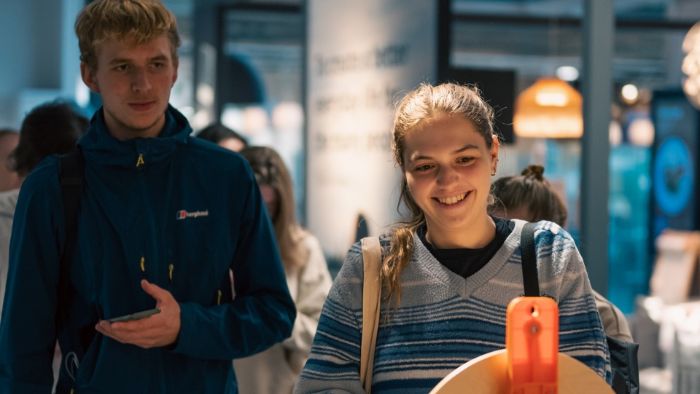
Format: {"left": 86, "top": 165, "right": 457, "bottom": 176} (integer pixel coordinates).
{"left": 75, "top": 0, "right": 180, "bottom": 69}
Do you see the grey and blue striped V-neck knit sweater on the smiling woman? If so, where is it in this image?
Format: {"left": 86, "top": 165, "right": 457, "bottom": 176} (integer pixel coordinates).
{"left": 295, "top": 220, "right": 611, "bottom": 394}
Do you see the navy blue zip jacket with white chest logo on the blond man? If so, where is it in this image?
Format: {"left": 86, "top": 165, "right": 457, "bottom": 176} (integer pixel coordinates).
{"left": 0, "top": 108, "right": 296, "bottom": 394}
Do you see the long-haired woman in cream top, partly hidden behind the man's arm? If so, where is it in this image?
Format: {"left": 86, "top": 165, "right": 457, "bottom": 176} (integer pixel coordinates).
{"left": 233, "top": 147, "right": 331, "bottom": 394}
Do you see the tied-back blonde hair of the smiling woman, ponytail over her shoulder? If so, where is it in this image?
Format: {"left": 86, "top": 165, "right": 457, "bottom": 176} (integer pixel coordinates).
{"left": 388, "top": 83, "right": 496, "bottom": 304}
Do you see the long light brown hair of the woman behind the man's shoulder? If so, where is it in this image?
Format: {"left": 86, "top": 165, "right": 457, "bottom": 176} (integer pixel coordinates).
{"left": 240, "top": 146, "right": 309, "bottom": 270}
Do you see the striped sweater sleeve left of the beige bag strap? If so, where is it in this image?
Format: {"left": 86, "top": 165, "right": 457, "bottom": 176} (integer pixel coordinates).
{"left": 294, "top": 243, "right": 364, "bottom": 394}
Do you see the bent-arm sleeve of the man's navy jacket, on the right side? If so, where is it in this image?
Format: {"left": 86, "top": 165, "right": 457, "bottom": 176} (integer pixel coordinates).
{"left": 173, "top": 166, "right": 296, "bottom": 360}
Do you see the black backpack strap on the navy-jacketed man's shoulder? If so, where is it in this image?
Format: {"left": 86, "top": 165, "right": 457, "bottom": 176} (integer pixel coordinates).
{"left": 58, "top": 147, "right": 85, "bottom": 274}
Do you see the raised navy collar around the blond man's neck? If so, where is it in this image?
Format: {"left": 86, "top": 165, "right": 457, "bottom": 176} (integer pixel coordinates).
{"left": 78, "top": 105, "right": 192, "bottom": 168}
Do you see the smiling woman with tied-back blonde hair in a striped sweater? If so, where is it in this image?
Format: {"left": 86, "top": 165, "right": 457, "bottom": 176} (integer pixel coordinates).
{"left": 296, "top": 84, "right": 610, "bottom": 393}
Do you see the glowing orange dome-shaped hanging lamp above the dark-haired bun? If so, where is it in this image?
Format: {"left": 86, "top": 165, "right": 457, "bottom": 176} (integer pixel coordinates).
{"left": 513, "top": 77, "right": 583, "bottom": 138}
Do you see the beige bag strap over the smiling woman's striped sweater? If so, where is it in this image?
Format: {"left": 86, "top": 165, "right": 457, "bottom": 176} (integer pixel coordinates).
{"left": 360, "top": 237, "right": 382, "bottom": 394}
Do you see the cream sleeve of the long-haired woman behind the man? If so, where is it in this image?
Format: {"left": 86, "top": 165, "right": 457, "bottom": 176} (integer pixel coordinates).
{"left": 283, "top": 234, "right": 333, "bottom": 359}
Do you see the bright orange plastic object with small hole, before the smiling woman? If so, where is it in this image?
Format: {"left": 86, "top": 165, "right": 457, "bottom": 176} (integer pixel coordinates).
{"left": 506, "top": 297, "right": 559, "bottom": 394}
